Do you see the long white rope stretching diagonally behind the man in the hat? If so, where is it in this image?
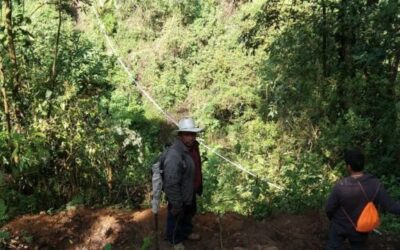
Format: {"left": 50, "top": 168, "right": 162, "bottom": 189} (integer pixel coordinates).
{"left": 92, "top": 5, "right": 284, "bottom": 190}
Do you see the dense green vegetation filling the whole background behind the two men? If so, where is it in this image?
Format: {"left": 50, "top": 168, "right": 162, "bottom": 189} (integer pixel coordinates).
{"left": 0, "top": 0, "right": 400, "bottom": 230}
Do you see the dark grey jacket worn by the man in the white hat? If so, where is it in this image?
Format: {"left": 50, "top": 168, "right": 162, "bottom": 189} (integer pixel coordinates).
{"left": 164, "top": 139, "right": 195, "bottom": 209}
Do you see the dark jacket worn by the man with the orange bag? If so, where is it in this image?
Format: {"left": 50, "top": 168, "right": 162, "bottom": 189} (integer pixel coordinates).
{"left": 326, "top": 174, "right": 400, "bottom": 232}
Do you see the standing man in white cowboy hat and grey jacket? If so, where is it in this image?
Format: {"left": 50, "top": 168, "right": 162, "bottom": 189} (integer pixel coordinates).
{"left": 164, "top": 118, "right": 203, "bottom": 249}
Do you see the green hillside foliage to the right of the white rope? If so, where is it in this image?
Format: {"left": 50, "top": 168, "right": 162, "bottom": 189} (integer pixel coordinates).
{"left": 99, "top": 0, "right": 398, "bottom": 215}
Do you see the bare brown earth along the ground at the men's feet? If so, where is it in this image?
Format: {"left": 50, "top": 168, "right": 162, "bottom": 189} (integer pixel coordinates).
{"left": 1, "top": 208, "right": 400, "bottom": 250}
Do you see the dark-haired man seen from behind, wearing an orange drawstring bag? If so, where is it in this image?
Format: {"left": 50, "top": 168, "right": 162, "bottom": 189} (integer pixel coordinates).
{"left": 326, "top": 149, "right": 400, "bottom": 250}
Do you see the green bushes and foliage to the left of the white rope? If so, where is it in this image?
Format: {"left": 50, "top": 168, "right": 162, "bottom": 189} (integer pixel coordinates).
{"left": 0, "top": 1, "right": 159, "bottom": 220}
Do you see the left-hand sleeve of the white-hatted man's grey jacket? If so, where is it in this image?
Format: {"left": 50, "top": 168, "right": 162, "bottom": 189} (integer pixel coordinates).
{"left": 164, "top": 150, "right": 183, "bottom": 209}
